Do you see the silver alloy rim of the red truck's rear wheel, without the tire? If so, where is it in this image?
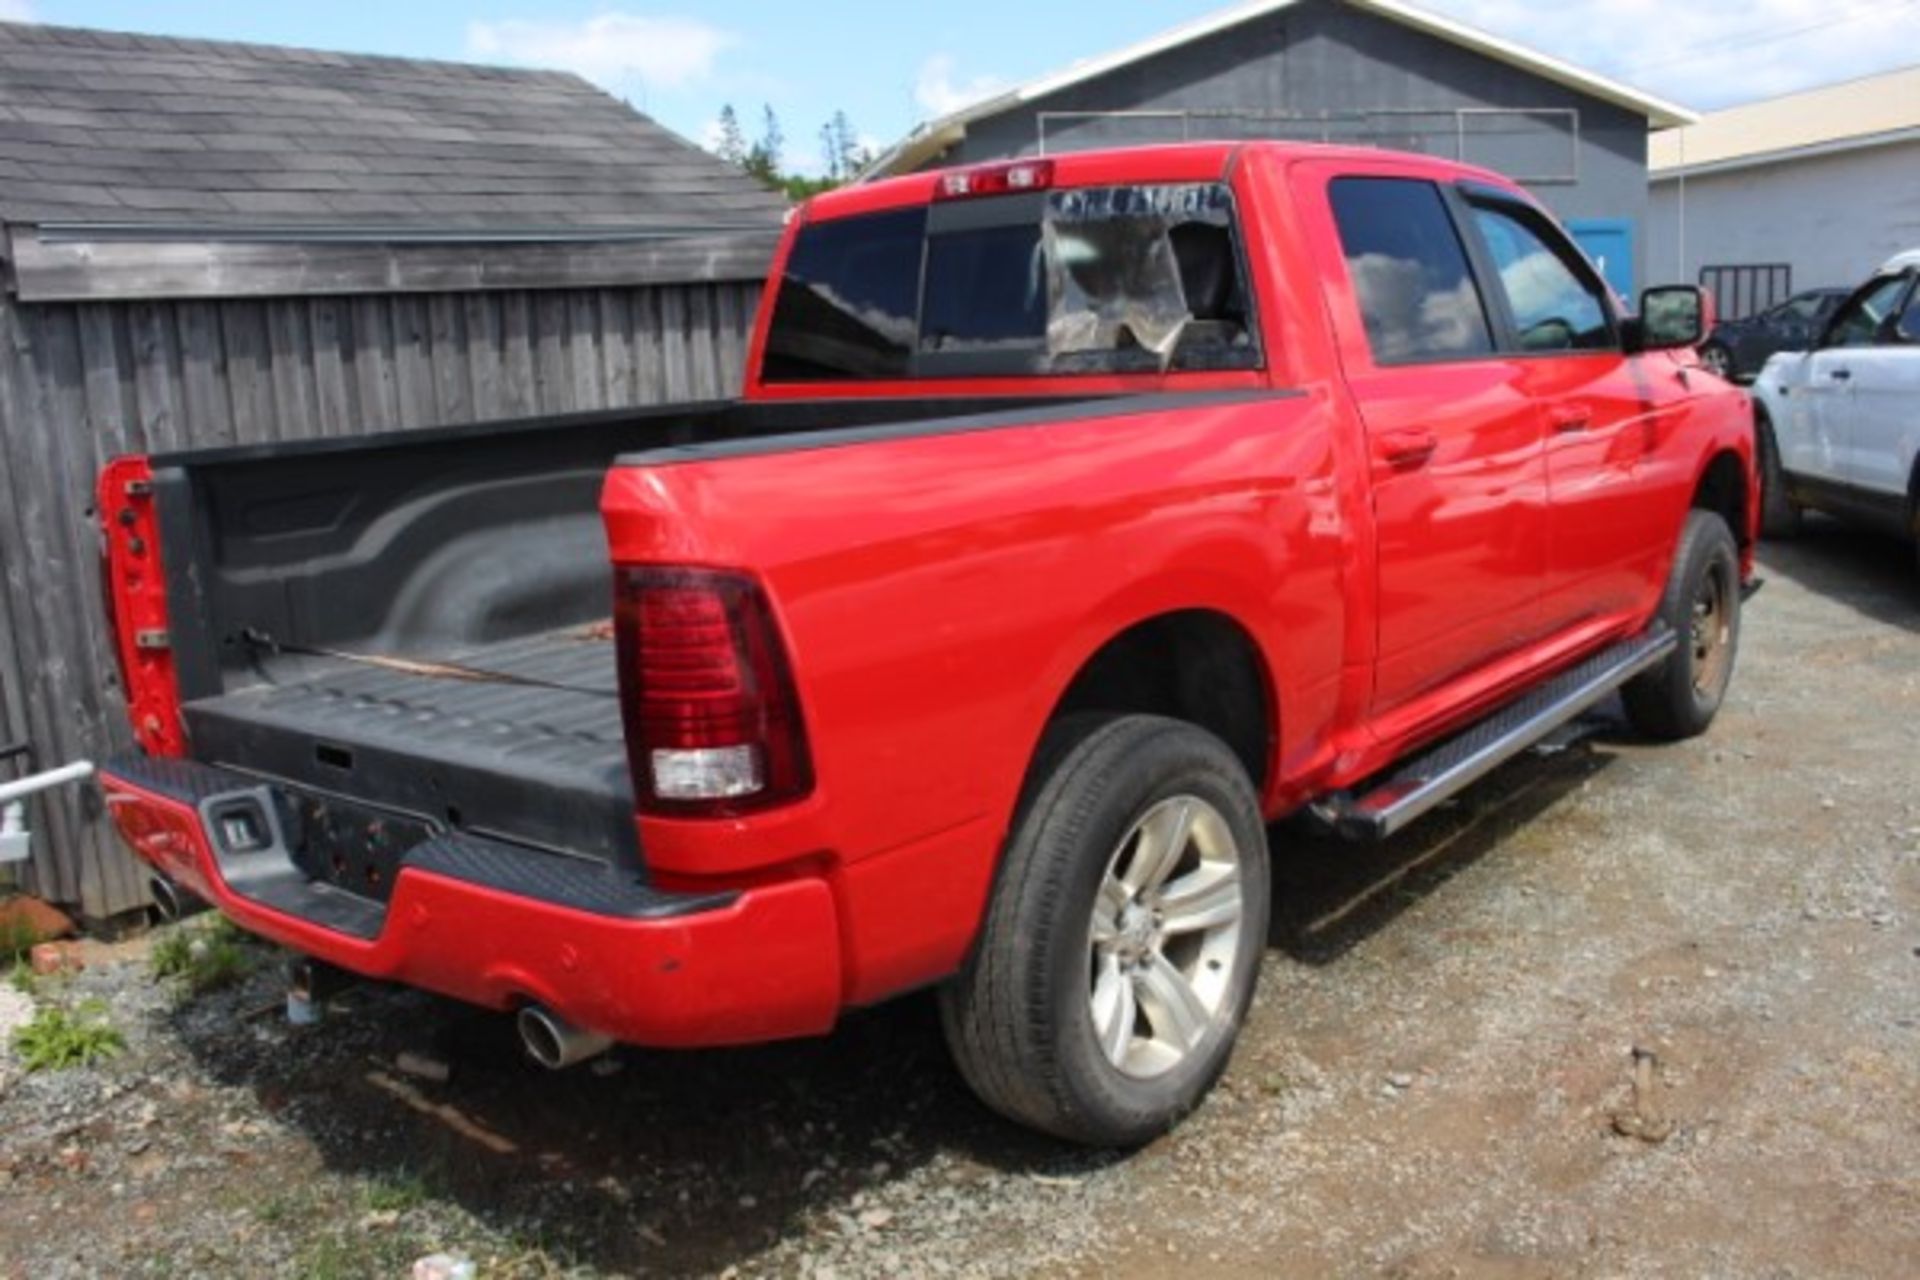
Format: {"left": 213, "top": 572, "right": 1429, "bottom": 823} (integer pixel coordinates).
{"left": 1087, "top": 794, "right": 1246, "bottom": 1079}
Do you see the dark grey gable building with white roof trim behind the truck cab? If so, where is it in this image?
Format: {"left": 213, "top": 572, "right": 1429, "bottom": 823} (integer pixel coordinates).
{"left": 872, "top": 0, "right": 1693, "bottom": 294}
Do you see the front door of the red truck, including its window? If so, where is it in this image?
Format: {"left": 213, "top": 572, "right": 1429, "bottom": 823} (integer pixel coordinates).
{"left": 1463, "top": 192, "right": 1692, "bottom": 629}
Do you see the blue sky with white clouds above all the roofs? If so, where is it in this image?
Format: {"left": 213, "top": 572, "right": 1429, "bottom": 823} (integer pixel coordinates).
{"left": 11, "top": 0, "right": 1920, "bottom": 173}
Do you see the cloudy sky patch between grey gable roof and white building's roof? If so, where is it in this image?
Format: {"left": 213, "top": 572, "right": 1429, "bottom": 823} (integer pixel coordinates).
{"left": 1427, "top": 0, "right": 1920, "bottom": 109}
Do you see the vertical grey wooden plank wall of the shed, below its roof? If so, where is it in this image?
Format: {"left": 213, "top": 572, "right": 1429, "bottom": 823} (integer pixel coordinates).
{"left": 0, "top": 280, "right": 758, "bottom": 919}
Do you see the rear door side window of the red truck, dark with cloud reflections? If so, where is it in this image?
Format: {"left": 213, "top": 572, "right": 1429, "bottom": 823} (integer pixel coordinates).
{"left": 1329, "top": 178, "right": 1494, "bottom": 365}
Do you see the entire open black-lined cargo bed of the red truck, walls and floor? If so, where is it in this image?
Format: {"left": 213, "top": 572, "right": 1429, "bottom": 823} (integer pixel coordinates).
{"left": 152, "top": 397, "right": 1083, "bottom": 871}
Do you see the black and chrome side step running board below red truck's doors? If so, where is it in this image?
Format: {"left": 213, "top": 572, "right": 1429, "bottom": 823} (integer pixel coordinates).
{"left": 1317, "top": 622, "right": 1676, "bottom": 841}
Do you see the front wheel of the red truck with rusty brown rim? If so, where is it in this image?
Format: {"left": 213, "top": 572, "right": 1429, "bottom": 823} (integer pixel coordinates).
{"left": 1620, "top": 510, "right": 1740, "bottom": 741}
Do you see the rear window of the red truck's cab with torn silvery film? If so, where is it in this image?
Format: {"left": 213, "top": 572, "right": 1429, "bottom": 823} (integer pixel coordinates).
{"left": 762, "top": 182, "right": 1261, "bottom": 382}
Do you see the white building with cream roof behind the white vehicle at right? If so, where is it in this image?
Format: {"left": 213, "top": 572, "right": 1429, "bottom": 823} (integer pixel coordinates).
{"left": 1647, "top": 65, "right": 1920, "bottom": 317}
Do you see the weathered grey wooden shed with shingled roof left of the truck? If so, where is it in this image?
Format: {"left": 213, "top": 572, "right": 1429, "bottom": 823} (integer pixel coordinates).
{"left": 0, "top": 25, "right": 783, "bottom": 919}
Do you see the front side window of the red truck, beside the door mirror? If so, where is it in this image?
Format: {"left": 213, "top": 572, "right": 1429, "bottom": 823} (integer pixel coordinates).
{"left": 1473, "top": 203, "right": 1617, "bottom": 351}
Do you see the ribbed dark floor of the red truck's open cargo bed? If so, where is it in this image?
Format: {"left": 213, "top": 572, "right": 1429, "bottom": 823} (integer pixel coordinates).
{"left": 184, "top": 624, "right": 636, "bottom": 862}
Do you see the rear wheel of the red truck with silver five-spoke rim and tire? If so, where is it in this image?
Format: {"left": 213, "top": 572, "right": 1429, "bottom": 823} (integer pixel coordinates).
{"left": 941, "top": 716, "right": 1271, "bottom": 1148}
